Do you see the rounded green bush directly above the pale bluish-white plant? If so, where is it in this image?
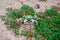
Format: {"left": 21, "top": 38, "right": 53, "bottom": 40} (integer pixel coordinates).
{"left": 21, "top": 5, "right": 35, "bottom": 16}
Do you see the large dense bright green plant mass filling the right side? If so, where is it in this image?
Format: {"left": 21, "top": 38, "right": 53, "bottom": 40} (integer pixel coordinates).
{"left": 35, "top": 8, "right": 60, "bottom": 40}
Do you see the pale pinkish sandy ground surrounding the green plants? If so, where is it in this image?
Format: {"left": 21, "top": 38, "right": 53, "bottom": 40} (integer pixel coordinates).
{"left": 0, "top": 0, "right": 60, "bottom": 40}
